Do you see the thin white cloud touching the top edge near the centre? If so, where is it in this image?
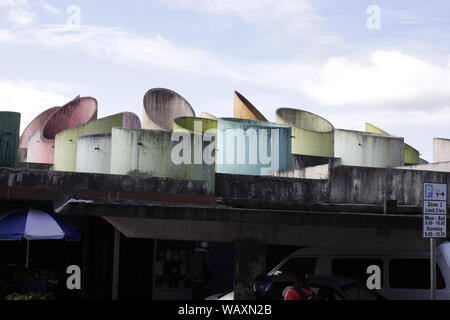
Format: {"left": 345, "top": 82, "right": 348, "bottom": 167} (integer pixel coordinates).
{"left": 160, "top": 0, "right": 321, "bottom": 29}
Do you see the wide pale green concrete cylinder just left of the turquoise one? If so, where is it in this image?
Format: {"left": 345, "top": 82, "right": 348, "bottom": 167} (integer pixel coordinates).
{"left": 111, "top": 128, "right": 215, "bottom": 193}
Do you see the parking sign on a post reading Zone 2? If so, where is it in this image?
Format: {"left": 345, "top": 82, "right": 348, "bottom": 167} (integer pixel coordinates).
{"left": 423, "top": 183, "right": 447, "bottom": 300}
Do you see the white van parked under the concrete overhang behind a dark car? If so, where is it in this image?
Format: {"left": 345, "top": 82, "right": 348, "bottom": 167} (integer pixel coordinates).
{"left": 268, "top": 241, "right": 450, "bottom": 300}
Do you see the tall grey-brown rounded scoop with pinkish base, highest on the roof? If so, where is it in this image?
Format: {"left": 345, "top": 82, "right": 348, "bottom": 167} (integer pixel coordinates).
{"left": 142, "top": 88, "right": 195, "bottom": 131}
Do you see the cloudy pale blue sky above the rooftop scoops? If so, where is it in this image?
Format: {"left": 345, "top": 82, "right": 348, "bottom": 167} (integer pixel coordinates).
{"left": 0, "top": 0, "right": 450, "bottom": 161}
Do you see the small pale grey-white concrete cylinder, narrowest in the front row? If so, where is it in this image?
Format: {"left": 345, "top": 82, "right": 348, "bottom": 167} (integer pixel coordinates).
{"left": 76, "top": 133, "right": 111, "bottom": 174}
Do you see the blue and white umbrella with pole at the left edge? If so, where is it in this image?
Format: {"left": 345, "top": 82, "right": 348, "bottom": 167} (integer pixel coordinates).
{"left": 0, "top": 208, "right": 81, "bottom": 268}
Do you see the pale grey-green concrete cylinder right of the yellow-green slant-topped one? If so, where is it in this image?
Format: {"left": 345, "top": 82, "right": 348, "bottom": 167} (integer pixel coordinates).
{"left": 334, "top": 129, "right": 405, "bottom": 168}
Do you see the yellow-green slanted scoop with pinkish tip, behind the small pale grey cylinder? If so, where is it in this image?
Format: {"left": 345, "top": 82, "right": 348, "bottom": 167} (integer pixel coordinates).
{"left": 54, "top": 112, "right": 141, "bottom": 172}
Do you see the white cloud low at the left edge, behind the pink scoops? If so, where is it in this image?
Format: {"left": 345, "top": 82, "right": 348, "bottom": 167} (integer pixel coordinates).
{"left": 0, "top": 80, "right": 70, "bottom": 131}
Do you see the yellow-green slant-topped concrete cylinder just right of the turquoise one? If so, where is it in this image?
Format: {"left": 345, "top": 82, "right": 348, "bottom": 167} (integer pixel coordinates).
{"left": 276, "top": 108, "right": 334, "bottom": 157}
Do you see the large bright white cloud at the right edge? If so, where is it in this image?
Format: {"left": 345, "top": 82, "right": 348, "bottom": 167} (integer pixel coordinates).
{"left": 301, "top": 50, "right": 450, "bottom": 109}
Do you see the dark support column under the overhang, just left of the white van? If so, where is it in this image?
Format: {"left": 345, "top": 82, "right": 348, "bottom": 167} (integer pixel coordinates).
{"left": 234, "top": 239, "right": 267, "bottom": 300}
